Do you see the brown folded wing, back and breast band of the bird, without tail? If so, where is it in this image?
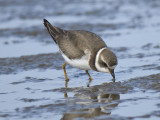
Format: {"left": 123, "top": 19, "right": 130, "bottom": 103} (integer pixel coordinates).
{"left": 58, "top": 30, "right": 107, "bottom": 70}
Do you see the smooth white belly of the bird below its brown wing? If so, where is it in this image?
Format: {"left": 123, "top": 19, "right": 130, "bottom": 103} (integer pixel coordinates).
{"left": 61, "top": 52, "right": 91, "bottom": 70}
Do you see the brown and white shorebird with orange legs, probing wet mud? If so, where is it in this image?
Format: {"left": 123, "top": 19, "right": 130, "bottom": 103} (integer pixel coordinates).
{"left": 43, "top": 19, "right": 118, "bottom": 86}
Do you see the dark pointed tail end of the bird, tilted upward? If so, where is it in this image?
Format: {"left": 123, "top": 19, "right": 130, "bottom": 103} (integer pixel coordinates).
{"left": 43, "top": 19, "right": 64, "bottom": 43}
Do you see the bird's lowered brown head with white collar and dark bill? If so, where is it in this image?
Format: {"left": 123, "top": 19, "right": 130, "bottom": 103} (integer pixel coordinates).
{"left": 95, "top": 48, "right": 118, "bottom": 79}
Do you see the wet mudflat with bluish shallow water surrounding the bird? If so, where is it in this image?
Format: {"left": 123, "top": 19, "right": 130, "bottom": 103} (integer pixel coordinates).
{"left": 0, "top": 0, "right": 160, "bottom": 120}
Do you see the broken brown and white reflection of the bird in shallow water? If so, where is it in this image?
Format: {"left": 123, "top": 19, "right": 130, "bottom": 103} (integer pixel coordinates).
{"left": 61, "top": 93, "right": 120, "bottom": 120}
